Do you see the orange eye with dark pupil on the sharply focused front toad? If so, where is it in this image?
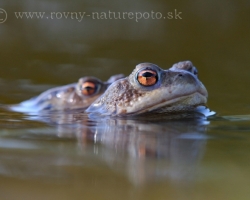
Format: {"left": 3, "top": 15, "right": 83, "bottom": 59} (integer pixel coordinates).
{"left": 137, "top": 69, "right": 158, "bottom": 86}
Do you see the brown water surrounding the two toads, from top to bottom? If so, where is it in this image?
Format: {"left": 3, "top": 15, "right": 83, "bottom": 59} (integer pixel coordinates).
{"left": 0, "top": 0, "right": 250, "bottom": 200}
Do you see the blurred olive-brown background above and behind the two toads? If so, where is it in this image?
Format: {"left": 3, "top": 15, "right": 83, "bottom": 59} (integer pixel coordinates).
{"left": 0, "top": 0, "right": 250, "bottom": 114}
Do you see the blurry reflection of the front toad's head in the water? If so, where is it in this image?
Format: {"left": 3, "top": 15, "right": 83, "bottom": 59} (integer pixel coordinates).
{"left": 77, "top": 119, "right": 206, "bottom": 185}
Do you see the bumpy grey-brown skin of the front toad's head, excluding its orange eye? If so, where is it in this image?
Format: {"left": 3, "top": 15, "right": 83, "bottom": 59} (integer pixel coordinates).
{"left": 86, "top": 61, "right": 208, "bottom": 116}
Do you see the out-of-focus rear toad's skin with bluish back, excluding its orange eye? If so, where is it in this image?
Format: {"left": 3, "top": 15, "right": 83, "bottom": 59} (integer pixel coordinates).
{"left": 8, "top": 74, "right": 124, "bottom": 112}
